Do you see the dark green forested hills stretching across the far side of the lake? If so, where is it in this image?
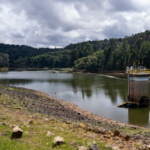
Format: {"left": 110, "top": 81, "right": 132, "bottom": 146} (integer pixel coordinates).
{"left": 0, "top": 30, "right": 150, "bottom": 71}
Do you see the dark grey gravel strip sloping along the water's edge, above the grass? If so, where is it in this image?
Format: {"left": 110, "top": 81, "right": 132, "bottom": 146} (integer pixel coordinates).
{"left": 0, "top": 85, "right": 146, "bottom": 129}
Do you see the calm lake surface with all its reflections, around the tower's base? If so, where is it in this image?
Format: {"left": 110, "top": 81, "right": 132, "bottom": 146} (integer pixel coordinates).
{"left": 0, "top": 71, "right": 150, "bottom": 127}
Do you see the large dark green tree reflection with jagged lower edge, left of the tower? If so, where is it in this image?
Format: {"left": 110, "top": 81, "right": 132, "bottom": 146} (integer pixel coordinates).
{"left": 48, "top": 74, "right": 128, "bottom": 104}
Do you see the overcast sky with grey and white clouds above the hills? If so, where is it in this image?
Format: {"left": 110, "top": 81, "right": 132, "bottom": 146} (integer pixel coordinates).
{"left": 0, "top": 0, "right": 150, "bottom": 47}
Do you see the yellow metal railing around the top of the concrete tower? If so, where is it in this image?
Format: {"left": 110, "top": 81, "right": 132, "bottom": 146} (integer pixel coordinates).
{"left": 125, "top": 69, "right": 150, "bottom": 75}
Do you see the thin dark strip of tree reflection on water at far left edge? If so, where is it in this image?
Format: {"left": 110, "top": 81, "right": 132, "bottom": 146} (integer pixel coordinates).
{"left": 0, "top": 79, "right": 33, "bottom": 85}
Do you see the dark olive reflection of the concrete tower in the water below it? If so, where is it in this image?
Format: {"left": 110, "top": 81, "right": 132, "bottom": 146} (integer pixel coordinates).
{"left": 128, "top": 107, "right": 150, "bottom": 125}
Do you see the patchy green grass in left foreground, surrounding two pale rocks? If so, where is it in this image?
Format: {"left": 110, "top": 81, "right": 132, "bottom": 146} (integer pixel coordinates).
{"left": 0, "top": 105, "right": 110, "bottom": 150}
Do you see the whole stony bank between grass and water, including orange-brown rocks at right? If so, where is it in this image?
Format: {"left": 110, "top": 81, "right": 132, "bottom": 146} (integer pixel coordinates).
{"left": 0, "top": 85, "right": 150, "bottom": 150}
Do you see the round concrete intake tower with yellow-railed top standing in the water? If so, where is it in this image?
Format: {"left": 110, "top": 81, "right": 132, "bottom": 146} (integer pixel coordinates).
{"left": 126, "top": 66, "right": 150, "bottom": 106}
